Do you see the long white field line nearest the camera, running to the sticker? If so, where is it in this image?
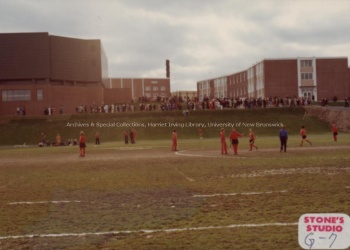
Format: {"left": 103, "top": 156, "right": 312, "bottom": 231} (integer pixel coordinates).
{"left": 0, "top": 222, "right": 298, "bottom": 240}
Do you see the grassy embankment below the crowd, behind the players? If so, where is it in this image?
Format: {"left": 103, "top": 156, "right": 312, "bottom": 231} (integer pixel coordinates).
{"left": 0, "top": 108, "right": 329, "bottom": 145}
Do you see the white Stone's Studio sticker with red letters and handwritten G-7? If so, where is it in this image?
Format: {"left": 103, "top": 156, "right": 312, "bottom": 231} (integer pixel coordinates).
{"left": 298, "top": 214, "right": 350, "bottom": 249}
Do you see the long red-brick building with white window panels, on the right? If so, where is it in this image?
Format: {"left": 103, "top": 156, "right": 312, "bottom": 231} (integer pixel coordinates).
{"left": 197, "top": 57, "right": 350, "bottom": 101}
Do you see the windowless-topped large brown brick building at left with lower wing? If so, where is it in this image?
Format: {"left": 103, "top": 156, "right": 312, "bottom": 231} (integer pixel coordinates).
{"left": 0, "top": 32, "right": 170, "bottom": 115}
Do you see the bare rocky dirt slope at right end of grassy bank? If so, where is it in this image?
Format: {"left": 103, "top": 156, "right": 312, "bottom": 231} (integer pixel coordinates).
{"left": 305, "top": 106, "right": 350, "bottom": 132}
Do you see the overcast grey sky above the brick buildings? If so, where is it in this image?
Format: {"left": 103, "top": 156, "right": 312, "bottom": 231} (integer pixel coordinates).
{"left": 0, "top": 0, "right": 350, "bottom": 91}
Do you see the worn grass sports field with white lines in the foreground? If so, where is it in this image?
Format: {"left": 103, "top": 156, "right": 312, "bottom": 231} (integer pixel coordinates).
{"left": 0, "top": 133, "right": 350, "bottom": 250}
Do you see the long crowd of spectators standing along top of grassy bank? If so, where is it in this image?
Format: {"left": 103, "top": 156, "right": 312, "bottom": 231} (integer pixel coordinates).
{"left": 37, "top": 96, "right": 350, "bottom": 115}
